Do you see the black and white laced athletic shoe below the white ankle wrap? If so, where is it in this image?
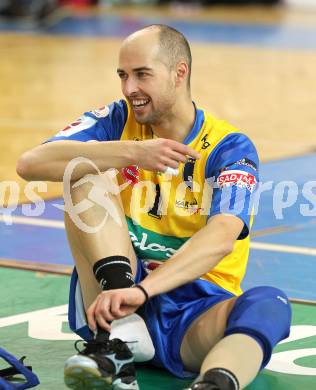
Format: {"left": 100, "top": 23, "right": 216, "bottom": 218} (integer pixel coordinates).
{"left": 64, "top": 338, "right": 139, "bottom": 390}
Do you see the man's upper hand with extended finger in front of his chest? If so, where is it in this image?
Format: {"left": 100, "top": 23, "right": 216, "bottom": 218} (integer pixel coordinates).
{"left": 135, "top": 138, "right": 201, "bottom": 172}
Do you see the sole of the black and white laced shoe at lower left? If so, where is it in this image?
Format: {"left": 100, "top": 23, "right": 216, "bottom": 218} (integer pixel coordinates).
{"left": 64, "top": 366, "right": 113, "bottom": 390}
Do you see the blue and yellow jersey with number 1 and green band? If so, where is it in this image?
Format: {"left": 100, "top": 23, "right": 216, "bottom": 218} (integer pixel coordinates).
{"left": 49, "top": 100, "right": 259, "bottom": 295}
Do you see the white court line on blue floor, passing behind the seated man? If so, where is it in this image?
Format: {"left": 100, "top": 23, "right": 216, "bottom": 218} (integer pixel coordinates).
{"left": 0, "top": 215, "right": 316, "bottom": 256}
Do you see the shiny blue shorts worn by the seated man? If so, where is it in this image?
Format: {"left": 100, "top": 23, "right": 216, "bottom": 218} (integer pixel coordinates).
{"left": 68, "top": 260, "right": 234, "bottom": 378}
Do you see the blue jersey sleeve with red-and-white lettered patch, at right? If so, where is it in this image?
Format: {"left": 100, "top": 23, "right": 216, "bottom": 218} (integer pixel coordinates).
{"left": 205, "top": 133, "right": 259, "bottom": 239}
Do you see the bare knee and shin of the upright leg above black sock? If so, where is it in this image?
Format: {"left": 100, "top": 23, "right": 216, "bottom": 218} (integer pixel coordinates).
{"left": 65, "top": 177, "right": 137, "bottom": 309}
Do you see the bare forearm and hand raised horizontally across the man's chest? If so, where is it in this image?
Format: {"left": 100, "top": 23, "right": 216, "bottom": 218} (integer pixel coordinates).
{"left": 17, "top": 138, "right": 199, "bottom": 181}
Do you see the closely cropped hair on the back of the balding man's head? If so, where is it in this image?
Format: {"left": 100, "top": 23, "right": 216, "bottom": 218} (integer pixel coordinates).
{"left": 144, "top": 24, "right": 192, "bottom": 88}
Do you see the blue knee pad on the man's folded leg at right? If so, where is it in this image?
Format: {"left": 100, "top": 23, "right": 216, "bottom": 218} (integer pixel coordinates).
{"left": 225, "top": 286, "right": 292, "bottom": 368}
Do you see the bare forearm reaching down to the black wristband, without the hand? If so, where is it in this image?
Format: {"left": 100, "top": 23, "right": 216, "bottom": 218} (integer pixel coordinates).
{"left": 140, "top": 214, "right": 243, "bottom": 297}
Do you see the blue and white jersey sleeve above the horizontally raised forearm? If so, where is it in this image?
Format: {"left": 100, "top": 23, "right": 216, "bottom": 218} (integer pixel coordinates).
{"left": 46, "top": 100, "right": 127, "bottom": 142}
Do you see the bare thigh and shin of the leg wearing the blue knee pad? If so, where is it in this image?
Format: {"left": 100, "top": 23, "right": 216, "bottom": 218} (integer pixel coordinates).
{"left": 181, "top": 298, "right": 263, "bottom": 388}
